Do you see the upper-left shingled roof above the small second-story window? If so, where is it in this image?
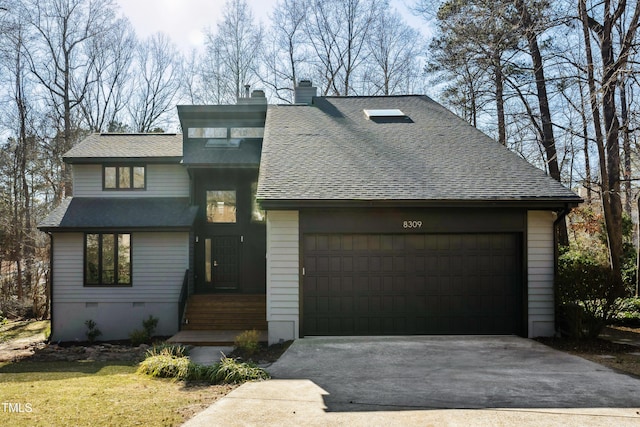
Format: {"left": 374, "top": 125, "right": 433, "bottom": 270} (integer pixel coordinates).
{"left": 64, "top": 133, "right": 182, "bottom": 163}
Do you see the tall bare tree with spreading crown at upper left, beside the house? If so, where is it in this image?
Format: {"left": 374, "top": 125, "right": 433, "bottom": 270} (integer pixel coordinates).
{"left": 20, "top": 0, "right": 116, "bottom": 200}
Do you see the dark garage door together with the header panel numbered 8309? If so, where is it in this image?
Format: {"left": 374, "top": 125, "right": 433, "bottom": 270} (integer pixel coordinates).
{"left": 300, "top": 209, "right": 527, "bottom": 336}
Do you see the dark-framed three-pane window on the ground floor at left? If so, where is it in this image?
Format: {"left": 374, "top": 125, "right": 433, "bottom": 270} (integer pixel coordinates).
{"left": 84, "top": 233, "right": 131, "bottom": 286}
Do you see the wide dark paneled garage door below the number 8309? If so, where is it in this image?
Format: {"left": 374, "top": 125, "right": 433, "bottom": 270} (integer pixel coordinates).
{"left": 302, "top": 234, "right": 522, "bottom": 335}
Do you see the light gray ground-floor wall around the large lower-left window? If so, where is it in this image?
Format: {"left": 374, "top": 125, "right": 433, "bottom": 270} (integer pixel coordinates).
{"left": 52, "top": 232, "right": 189, "bottom": 341}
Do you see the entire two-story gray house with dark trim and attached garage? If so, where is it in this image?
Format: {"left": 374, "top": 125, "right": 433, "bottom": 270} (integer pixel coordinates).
{"left": 40, "top": 82, "right": 581, "bottom": 343}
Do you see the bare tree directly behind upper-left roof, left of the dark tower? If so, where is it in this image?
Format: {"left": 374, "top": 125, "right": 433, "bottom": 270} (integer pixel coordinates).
{"left": 127, "top": 33, "right": 182, "bottom": 132}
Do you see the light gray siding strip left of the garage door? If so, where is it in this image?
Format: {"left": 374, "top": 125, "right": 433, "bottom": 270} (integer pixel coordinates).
{"left": 267, "top": 211, "right": 300, "bottom": 344}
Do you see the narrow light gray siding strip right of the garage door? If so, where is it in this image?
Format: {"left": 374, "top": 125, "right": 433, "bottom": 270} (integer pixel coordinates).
{"left": 527, "top": 211, "right": 555, "bottom": 338}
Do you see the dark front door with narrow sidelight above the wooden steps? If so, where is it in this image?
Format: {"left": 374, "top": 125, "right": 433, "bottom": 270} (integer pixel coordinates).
{"left": 203, "top": 236, "right": 240, "bottom": 291}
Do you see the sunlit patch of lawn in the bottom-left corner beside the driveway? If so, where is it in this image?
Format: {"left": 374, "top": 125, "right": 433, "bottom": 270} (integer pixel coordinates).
{"left": 0, "top": 361, "right": 233, "bottom": 427}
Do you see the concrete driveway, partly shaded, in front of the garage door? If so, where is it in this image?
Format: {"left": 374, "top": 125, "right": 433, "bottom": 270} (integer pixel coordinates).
{"left": 187, "top": 336, "right": 640, "bottom": 427}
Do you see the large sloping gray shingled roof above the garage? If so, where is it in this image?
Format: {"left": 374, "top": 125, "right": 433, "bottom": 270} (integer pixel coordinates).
{"left": 257, "top": 96, "right": 581, "bottom": 208}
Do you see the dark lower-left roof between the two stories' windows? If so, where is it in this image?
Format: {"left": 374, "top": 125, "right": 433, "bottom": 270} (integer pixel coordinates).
{"left": 38, "top": 197, "right": 198, "bottom": 231}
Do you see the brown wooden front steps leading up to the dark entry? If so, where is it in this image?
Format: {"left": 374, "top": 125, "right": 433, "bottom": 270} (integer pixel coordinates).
{"left": 181, "top": 294, "right": 267, "bottom": 335}
